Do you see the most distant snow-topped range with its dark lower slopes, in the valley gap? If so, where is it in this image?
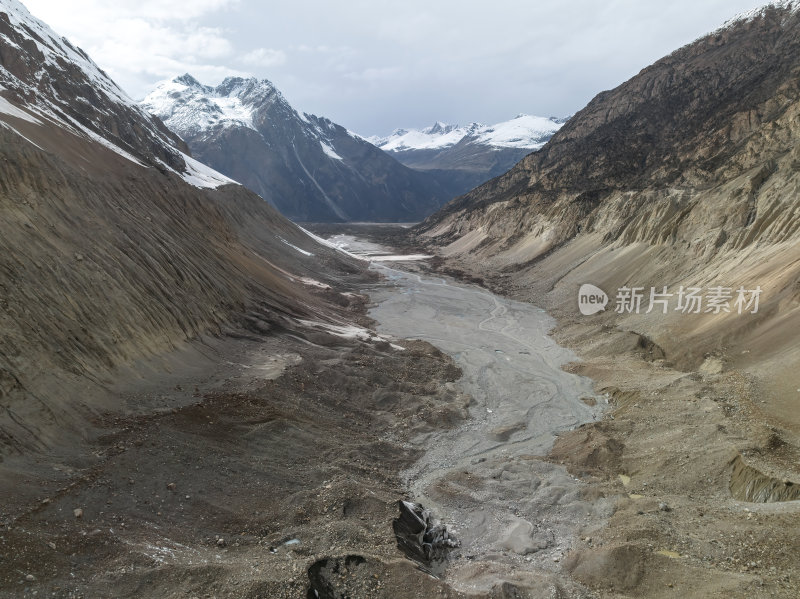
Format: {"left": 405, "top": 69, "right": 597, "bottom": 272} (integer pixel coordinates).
{"left": 368, "top": 114, "right": 566, "bottom": 199}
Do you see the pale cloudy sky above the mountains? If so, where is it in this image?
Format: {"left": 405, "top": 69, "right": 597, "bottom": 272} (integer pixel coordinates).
{"left": 23, "top": 0, "right": 766, "bottom": 135}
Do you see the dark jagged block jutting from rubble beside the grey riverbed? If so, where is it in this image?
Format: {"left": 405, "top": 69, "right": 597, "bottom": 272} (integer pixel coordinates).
{"left": 392, "top": 500, "right": 460, "bottom": 564}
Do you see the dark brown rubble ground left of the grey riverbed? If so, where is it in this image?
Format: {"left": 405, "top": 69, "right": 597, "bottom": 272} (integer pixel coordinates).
{"left": 0, "top": 274, "right": 465, "bottom": 599}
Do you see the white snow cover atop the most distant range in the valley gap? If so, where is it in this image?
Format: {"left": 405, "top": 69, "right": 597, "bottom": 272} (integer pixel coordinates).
{"left": 367, "top": 114, "right": 565, "bottom": 152}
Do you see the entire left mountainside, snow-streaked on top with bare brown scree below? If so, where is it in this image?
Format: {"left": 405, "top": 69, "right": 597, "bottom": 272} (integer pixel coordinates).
{"left": 0, "top": 0, "right": 358, "bottom": 461}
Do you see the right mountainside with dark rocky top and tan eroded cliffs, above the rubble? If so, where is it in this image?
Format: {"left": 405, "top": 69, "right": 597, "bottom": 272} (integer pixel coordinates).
{"left": 418, "top": 3, "right": 800, "bottom": 406}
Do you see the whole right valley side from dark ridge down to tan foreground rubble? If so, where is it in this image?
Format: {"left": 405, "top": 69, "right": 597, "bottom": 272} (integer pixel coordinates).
{"left": 417, "top": 2, "right": 800, "bottom": 598}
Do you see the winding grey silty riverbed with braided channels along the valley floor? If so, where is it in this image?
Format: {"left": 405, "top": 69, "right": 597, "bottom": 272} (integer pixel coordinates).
{"left": 337, "top": 236, "right": 609, "bottom": 591}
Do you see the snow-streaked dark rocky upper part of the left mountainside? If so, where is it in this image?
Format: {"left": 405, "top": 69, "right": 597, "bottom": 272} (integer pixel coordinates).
{"left": 0, "top": 0, "right": 233, "bottom": 187}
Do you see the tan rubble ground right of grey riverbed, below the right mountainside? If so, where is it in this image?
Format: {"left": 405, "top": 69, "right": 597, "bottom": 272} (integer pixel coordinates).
{"left": 394, "top": 226, "right": 800, "bottom": 598}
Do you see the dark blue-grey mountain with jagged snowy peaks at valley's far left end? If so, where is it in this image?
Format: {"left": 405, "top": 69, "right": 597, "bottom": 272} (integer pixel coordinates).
{"left": 142, "top": 75, "right": 457, "bottom": 222}
